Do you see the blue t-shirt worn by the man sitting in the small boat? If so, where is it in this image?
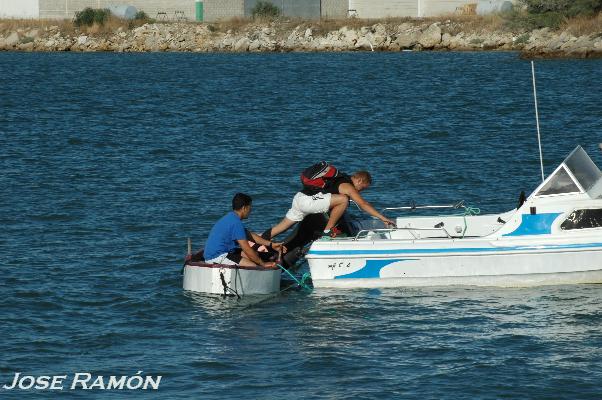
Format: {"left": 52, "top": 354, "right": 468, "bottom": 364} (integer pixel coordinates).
{"left": 205, "top": 211, "right": 247, "bottom": 260}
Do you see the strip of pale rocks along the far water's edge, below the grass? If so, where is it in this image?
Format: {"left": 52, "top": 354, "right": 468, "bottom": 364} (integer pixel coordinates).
{"left": 0, "top": 20, "right": 602, "bottom": 58}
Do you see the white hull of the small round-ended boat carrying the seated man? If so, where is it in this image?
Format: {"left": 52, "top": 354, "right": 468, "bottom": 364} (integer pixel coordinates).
{"left": 183, "top": 263, "right": 281, "bottom": 296}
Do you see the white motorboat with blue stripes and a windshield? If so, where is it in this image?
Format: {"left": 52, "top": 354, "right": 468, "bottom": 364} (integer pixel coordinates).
{"left": 306, "top": 146, "right": 602, "bottom": 288}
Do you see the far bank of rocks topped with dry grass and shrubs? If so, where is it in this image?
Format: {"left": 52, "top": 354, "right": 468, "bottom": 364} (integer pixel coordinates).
{"left": 0, "top": 8, "right": 602, "bottom": 58}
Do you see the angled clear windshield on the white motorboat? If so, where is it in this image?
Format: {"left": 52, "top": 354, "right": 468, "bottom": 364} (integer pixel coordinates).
{"left": 537, "top": 146, "right": 602, "bottom": 196}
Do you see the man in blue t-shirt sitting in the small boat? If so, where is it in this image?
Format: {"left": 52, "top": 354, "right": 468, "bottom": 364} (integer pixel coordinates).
{"left": 205, "top": 193, "right": 285, "bottom": 268}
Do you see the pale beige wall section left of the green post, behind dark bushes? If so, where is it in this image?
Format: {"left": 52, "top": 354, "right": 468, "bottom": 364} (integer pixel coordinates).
{"left": 39, "top": 0, "right": 195, "bottom": 21}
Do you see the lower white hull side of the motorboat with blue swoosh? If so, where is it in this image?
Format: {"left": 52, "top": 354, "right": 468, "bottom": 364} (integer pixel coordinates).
{"left": 308, "top": 241, "right": 602, "bottom": 288}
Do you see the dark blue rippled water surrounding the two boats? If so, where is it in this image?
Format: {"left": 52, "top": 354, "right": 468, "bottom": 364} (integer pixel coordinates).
{"left": 0, "top": 53, "right": 602, "bottom": 399}
